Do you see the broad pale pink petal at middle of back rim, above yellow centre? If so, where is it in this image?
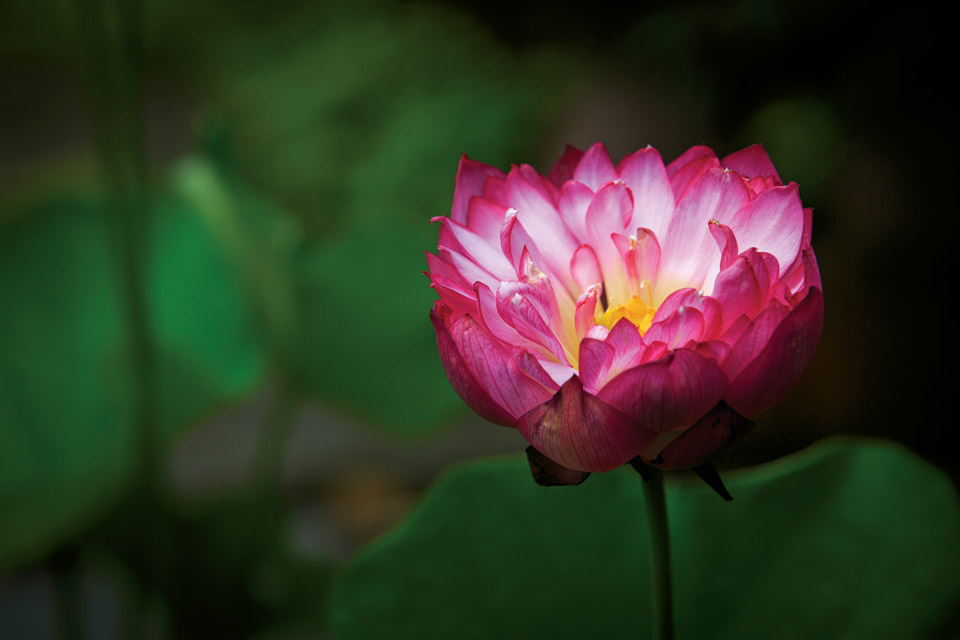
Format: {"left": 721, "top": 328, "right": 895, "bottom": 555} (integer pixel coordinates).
{"left": 617, "top": 147, "right": 676, "bottom": 237}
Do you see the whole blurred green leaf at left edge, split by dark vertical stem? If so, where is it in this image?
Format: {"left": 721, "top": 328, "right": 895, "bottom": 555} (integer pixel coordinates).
{"left": 0, "top": 189, "right": 266, "bottom": 572}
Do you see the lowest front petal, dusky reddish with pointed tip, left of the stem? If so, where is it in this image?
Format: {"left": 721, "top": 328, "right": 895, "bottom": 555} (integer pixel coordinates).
{"left": 517, "top": 376, "right": 656, "bottom": 472}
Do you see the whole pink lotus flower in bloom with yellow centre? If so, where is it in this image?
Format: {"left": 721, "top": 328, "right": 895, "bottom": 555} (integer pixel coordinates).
{"left": 427, "top": 143, "right": 823, "bottom": 475}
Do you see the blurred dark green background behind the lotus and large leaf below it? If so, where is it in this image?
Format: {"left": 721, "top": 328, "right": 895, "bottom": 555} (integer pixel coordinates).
{"left": 0, "top": 0, "right": 960, "bottom": 638}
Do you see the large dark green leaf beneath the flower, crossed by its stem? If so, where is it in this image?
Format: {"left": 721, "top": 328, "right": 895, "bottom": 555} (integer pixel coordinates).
{"left": 329, "top": 441, "right": 960, "bottom": 640}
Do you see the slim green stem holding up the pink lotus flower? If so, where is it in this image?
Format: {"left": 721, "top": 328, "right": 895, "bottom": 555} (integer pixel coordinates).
{"left": 643, "top": 467, "right": 673, "bottom": 640}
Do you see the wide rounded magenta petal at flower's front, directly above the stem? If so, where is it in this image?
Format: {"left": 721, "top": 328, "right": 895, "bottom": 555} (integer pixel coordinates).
{"left": 599, "top": 349, "right": 727, "bottom": 433}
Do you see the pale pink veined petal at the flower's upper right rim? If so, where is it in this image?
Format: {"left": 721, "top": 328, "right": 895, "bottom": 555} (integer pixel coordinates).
{"left": 732, "top": 182, "right": 804, "bottom": 276}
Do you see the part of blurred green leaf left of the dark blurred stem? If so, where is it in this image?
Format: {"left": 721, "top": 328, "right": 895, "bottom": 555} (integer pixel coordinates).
{"left": 0, "top": 200, "right": 134, "bottom": 573}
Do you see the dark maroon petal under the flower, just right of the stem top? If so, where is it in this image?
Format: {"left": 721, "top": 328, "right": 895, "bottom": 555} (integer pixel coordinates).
{"left": 652, "top": 402, "right": 754, "bottom": 469}
